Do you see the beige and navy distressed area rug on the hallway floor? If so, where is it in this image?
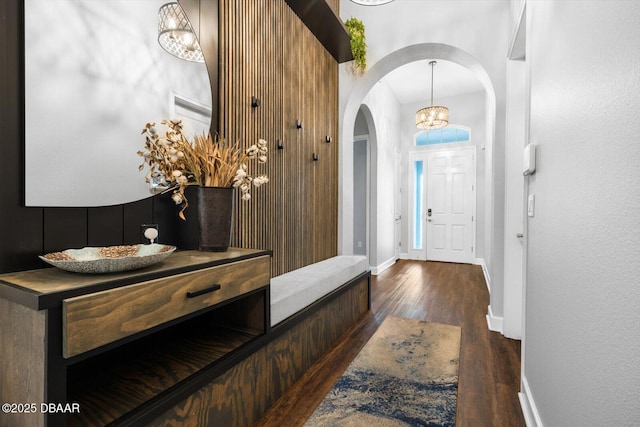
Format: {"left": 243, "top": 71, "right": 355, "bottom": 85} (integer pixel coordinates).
{"left": 305, "top": 316, "right": 460, "bottom": 427}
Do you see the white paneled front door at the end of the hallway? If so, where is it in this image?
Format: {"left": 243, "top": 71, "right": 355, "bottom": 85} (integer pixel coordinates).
{"left": 425, "top": 148, "right": 475, "bottom": 263}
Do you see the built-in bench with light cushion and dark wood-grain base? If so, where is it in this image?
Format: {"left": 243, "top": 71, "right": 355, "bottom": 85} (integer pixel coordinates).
{"left": 158, "top": 256, "right": 371, "bottom": 426}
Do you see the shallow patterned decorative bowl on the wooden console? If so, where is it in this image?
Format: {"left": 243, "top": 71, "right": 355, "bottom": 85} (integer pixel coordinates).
{"left": 40, "top": 243, "right": 176, "bottom": 274}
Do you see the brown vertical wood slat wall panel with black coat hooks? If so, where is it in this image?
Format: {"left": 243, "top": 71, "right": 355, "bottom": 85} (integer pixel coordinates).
{"left": 219, "top": 0, "right": 338, "bottom": 275}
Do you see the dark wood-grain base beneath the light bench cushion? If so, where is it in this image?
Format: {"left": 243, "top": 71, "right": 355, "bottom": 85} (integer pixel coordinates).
{"left": 152, "top": 272, "right": 371, "bottom": 426}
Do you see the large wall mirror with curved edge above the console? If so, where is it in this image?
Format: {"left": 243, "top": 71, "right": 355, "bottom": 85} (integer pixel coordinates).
{"left": 24, "top": 0, "right": 212, "bottom": 207}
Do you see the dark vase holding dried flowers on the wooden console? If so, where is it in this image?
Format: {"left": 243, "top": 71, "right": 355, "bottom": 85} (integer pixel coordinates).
{"left": 178, "top": 187, "right": 235, "bottom": 252}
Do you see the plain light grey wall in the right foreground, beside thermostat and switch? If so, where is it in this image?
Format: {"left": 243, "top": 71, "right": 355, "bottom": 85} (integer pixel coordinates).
{"left": 523, "top": 0, "right": 640, "bottom": 426}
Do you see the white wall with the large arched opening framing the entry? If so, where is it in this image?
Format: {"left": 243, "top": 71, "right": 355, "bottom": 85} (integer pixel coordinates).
{"left": 338, "top": 0, "right": 509, "bottom": 315}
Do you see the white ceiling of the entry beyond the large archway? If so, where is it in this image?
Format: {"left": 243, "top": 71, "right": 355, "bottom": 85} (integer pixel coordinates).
{"left": 381, "top": 60, "right": 484, "bottom": 105}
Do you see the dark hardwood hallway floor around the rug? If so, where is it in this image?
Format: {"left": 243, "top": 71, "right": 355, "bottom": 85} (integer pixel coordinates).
{"left": 256, "top": 260, "right": 525, "bottom": 427}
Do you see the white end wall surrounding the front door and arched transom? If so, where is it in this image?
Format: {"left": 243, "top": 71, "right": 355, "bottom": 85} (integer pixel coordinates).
{"left": 400, "top": 92, "right": 486, "bottom": 258}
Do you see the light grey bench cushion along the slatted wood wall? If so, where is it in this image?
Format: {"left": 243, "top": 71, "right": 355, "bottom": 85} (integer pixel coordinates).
{"left": 271, "top": 255, "right": 368, "bottom": 326}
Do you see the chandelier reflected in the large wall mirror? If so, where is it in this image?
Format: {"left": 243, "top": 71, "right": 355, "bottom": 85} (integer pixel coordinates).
{"left": 158, "top": 2, "right": 204, "bottom": 62}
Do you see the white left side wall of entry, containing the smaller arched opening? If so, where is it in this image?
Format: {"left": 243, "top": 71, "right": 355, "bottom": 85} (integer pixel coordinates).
{"left": 362, "top": 82, "right": 400, "bottom": 274}
